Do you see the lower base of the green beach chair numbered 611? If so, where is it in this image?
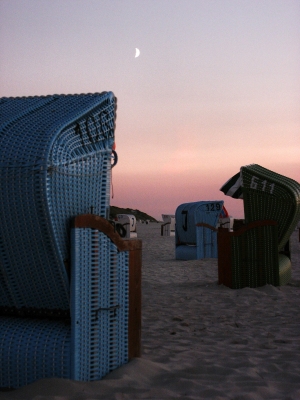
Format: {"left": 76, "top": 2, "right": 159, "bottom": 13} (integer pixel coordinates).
{"left": 218, "top": 221, "right": 291, "bottom": 289}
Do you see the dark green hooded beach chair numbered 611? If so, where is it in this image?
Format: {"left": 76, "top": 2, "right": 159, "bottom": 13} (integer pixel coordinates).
{"left": 218, "top": 164, "right": 300, "bottom": 289}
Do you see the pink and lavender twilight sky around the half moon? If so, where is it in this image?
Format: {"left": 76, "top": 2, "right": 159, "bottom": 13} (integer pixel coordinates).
{"left": 0, "top": 0, "right": 300, "bottom": 219}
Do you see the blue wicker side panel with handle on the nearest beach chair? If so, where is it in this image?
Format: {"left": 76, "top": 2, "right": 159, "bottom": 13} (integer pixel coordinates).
{"left": 71, "top": 228, "right": 129, "bottom": 381}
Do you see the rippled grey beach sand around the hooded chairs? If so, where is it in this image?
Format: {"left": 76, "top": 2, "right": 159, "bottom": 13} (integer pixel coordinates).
{"left": 0, "top": 223, "right": 300, "bottom": 400}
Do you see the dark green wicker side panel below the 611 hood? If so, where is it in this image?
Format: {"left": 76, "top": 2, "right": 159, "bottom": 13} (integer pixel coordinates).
{"left": 231, "top": 225, "right": 279, "bottom": 289}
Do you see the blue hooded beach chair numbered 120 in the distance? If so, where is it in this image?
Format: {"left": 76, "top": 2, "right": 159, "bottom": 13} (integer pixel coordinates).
{"left": 175, "top": 200, "right": 224, "bottom": 260}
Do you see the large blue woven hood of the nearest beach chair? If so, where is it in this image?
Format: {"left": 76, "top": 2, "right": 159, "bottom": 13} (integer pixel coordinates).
{"left": 0, "top": 92, "right": 116, "bottom": 310}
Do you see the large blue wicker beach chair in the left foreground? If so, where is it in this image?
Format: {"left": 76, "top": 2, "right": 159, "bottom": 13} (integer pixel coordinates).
{"left": 0, "top": 92, "right": 141, "bottom": 388}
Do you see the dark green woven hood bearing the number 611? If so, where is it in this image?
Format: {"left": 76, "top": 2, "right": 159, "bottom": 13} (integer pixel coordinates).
{"left": 241, "top": 164, "right": 300, "bottom": 250}
